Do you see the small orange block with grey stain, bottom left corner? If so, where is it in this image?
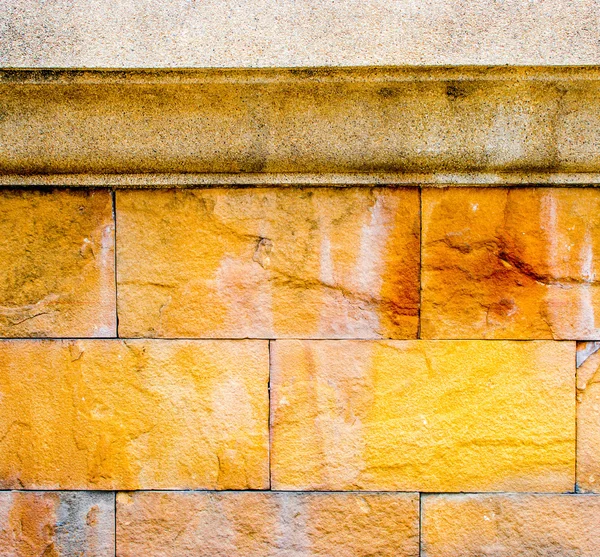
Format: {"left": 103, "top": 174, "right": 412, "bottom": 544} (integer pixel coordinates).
{"left": 0, "top": 491, "right": 115, "bottom": 557}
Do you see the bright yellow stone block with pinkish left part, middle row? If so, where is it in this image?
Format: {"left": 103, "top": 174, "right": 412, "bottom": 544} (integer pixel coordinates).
{"left": 271, "top": 340, "right": 575, "bottom": 491}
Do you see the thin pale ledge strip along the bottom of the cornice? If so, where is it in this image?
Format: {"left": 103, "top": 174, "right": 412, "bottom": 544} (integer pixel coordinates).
{"left": 0, "top": 170, "right": 600, "bottom": 188}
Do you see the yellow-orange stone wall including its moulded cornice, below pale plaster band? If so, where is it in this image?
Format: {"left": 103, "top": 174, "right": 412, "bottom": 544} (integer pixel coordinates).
{"left": 0, "top": 68, "right": 600, "bottom": 557}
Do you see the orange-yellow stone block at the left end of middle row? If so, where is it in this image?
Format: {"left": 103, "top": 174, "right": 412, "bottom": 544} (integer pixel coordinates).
{"left": 0, "top": 340, "right": 268, "bottom": 489}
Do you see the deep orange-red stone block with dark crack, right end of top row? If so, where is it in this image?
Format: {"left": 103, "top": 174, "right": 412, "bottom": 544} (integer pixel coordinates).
{"left": 421, "top": 188, "right": 600, "bottom": 340}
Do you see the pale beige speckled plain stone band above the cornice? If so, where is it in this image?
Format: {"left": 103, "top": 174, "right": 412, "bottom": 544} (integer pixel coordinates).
{"left": 0, "top": 0, "right": 600, "bottom": 68}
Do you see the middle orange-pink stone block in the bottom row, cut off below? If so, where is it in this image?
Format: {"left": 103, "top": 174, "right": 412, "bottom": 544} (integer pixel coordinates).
{"left": 117, "top": 492, "right": 419, "bottom": 557}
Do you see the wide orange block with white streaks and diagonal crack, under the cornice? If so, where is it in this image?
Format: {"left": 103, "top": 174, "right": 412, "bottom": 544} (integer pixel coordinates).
{"left": 117, "top": 188, "right": 419, "bottom": 338}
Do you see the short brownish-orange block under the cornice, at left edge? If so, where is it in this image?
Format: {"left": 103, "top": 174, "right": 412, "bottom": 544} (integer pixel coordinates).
{"left": 0, "top": 190, "right": 116, "bottom": 337}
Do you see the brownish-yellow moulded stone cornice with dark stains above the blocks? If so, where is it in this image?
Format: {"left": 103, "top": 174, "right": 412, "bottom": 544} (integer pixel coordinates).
{"left": 0, "top": 67, "right": 600, "bottom": 186}
